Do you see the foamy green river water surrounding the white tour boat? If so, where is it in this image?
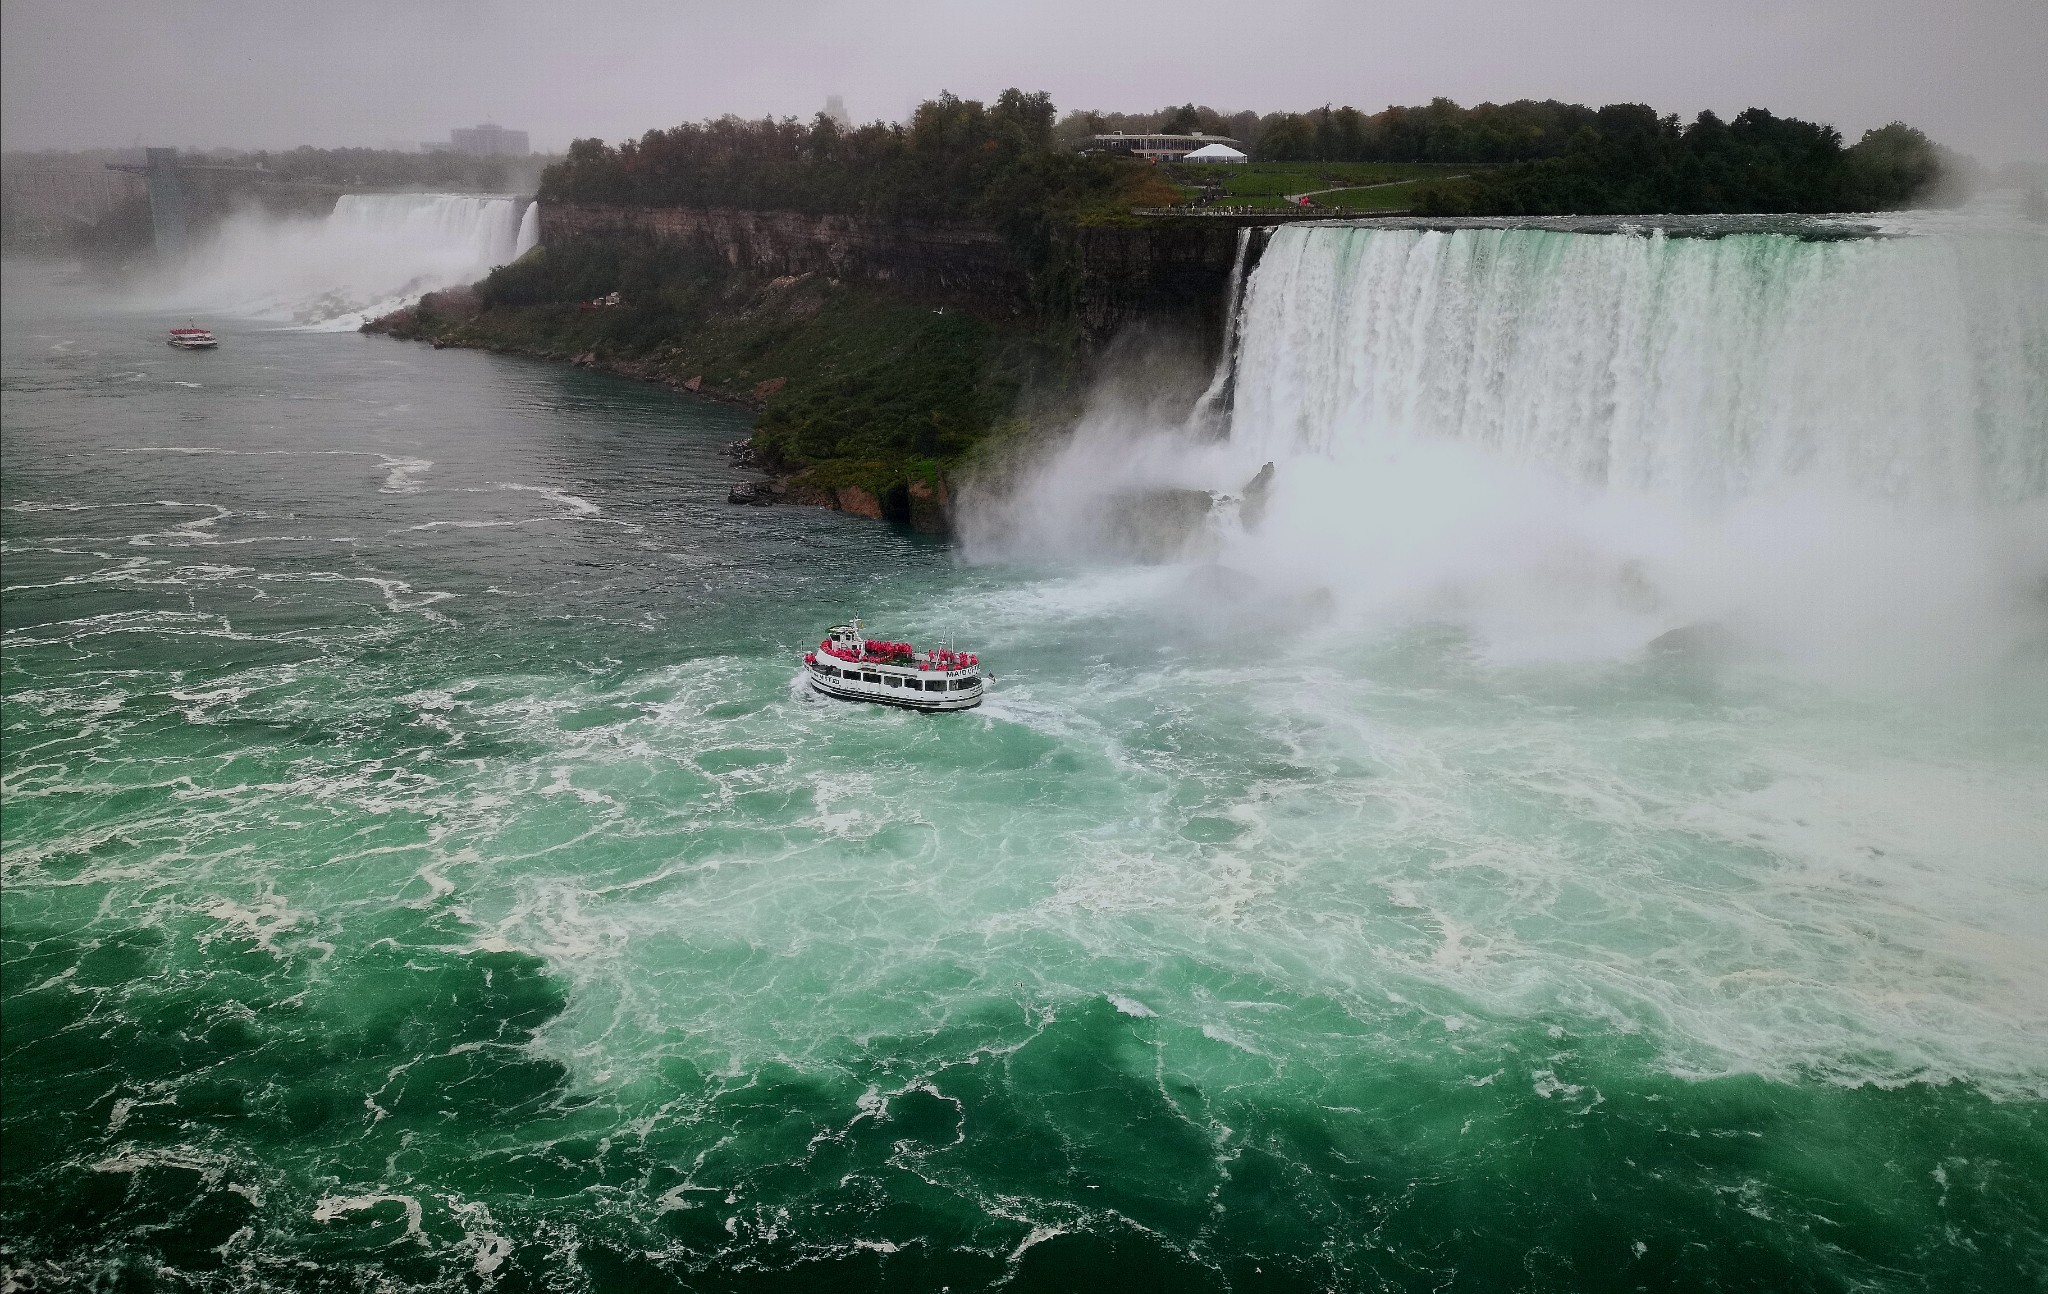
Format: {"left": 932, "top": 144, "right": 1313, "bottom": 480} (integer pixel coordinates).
{"left": 0, "top": 274, "right": 2048, "bottom": 1290}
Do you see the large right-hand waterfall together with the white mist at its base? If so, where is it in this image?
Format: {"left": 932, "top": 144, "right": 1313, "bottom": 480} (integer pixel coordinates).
{"left": 971, "top": 219, "right": 2048, "bottom": 686}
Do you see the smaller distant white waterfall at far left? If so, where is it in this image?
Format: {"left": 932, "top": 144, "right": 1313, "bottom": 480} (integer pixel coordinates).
{"left": 172, "top": 192, "right": 539, "bottom": 328}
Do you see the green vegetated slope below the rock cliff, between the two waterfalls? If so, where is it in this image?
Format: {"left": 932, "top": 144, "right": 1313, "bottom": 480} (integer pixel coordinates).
{"left": 385, "top": 238, "right": 1073, "bottom": 513}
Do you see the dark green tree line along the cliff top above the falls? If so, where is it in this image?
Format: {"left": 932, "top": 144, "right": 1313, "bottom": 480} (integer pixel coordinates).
{"left": 539, "top": 90, "right": 1946, "bottom": 223}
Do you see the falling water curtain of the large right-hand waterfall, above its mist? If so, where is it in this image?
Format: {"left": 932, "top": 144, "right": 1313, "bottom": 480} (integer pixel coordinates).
{"left": 1233, "top": 227, "right": 2048, "bottom": 504}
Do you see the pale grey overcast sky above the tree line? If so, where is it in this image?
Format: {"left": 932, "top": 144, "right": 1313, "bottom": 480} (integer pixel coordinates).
{"left": 12, "top": 0, "right": 2048, "bottom": 162}
